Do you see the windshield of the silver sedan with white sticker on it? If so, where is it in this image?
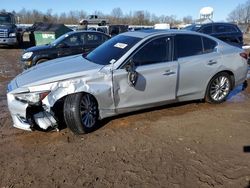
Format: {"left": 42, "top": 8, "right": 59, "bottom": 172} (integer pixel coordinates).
{"left": 86, "top": 35, "right": 141, "bottom": 65}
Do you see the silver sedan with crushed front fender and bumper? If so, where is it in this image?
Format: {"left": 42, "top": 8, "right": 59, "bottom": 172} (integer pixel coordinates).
{"left": 7, "top": 30, "right": 248, "bottom": 134}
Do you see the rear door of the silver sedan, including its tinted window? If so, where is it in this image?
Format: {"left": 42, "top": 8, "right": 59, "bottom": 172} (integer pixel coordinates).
{"left": 175, "top": 34, "right": 222, "bottom": 100}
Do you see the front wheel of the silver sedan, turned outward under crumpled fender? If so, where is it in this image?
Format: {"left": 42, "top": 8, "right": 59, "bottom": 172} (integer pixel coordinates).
{"left": 63, "top": 93, "right": 99, "bottom": 134}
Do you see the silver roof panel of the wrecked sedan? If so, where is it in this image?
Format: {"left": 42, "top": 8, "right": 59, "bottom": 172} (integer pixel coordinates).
{"left": 121, "top": 29, "right": 205, "bottom": 38}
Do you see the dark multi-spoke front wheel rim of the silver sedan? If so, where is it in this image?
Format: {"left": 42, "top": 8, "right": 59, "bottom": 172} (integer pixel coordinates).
{"left": 80, "top": 95, "right": 97, "bottom": 128}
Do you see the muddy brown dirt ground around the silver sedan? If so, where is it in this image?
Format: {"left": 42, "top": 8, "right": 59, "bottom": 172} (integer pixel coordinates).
{"left": 0, "top": 49, "right": 250, "bottom": 188}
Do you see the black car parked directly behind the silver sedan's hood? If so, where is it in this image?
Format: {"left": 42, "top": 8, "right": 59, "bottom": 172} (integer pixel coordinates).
{"left": 21, "top": 31, "right": 110, "bottom": 69}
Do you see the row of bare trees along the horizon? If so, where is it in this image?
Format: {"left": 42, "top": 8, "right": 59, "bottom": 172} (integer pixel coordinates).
{"left": 0, "top": 7, "right": 193, "bottom": 26}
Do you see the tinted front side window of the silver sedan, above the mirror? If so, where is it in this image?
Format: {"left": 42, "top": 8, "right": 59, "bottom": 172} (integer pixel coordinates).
{"left": 133, "top": 37, "right": 171, "bottom": 66}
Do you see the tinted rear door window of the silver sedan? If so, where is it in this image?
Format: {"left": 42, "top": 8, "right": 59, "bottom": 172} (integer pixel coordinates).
{"left": 175, "top": 35, "right": 203, "bottom": 58}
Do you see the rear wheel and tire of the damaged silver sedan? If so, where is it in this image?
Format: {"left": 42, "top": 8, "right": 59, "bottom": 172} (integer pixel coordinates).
{"left": 205, "top": 72, "right": 232, "bottom": 104}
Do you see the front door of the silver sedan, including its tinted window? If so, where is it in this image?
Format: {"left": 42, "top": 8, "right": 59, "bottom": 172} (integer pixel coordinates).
{"left": 113, "top": 36, "right": 178, "bottom": 113}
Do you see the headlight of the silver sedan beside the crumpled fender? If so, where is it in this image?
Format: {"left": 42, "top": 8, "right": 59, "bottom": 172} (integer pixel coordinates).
{"left": 15, "top": 91, "right": 49, "bottom": 104}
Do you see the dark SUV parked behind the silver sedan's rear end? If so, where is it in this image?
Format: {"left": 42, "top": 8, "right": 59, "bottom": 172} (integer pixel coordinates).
{"left": 184, "top": 22, "right": 243, "bottom": 47}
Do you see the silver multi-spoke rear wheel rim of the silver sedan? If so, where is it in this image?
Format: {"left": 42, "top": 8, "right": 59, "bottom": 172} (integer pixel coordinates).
{"left": 210, "top": 76, "right": 230, "bottom": 101}
